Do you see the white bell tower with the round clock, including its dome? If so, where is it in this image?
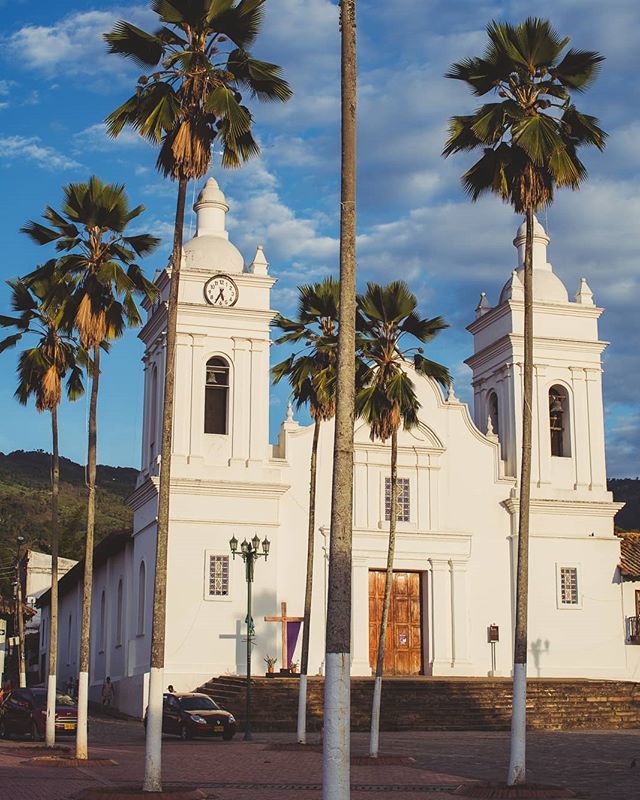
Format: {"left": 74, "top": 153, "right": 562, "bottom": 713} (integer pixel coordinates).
{"left": 139, "top": 178, "right": 275, "bottom": 482}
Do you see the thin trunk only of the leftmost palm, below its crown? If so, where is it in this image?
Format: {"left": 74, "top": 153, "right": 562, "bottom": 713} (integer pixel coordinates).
{"left": 45, "top": 406, "right": 60, "bottom": 747}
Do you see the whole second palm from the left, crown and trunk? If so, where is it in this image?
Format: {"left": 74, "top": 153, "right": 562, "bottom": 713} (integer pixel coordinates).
{"left": 22, "top": 176, "right": 160, "bottom": 759}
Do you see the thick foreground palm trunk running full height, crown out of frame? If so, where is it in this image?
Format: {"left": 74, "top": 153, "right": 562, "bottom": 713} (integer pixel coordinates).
{"left": 322, "top": 0, "right": 356, "bottom": 800}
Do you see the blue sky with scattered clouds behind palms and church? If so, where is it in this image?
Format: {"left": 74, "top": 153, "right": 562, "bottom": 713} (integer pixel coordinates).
{"left": 0, "top": 0, "right": 640, "bottom": 476}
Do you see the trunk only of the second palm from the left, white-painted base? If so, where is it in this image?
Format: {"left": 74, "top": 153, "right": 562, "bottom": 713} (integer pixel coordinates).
{"left": 76, "top": 344, "right": 100, "bottom": 759}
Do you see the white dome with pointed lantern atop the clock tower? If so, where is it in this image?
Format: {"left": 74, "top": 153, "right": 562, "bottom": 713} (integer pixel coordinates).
{"left": 183, "top": 178, "right": 244, "bottom": 272}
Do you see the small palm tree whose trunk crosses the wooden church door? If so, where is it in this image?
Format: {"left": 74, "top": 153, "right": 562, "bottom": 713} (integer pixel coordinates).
{"left": 356, "top": 281, "right": 451, "bottom": 758}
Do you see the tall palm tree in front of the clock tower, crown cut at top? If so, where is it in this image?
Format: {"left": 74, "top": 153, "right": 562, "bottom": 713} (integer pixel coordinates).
{"left": 104, "top": 0, "right": 291, "bottom": 791}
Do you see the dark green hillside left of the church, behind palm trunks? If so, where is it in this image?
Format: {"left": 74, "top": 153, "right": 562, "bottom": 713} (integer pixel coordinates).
{"left": 0, "top": 450, "right": 138, "bottom": 594}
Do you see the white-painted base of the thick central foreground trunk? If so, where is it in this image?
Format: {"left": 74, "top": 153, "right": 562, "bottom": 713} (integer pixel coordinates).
{"left": 322, "top": 653, "right": 351, "bottom": 800}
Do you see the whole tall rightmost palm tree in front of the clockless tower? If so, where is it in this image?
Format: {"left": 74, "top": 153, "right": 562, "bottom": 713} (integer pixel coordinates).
{"left": 443, "top": 17, "right": 606, "bottom": 785}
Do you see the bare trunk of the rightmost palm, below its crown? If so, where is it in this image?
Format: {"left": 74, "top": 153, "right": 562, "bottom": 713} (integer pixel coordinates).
{"left": 507, "top": 207, "right": 533, "bottom": 786}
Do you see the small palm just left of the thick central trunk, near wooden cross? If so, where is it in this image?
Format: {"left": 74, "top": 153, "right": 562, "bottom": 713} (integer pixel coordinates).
{"left": 271, "top": 277, "right": 340, "bottom": 744}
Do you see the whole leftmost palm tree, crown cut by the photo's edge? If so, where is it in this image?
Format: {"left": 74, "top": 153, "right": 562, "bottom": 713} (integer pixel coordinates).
{"left": 0, "top": 272, "right": 87, "bottom": 747}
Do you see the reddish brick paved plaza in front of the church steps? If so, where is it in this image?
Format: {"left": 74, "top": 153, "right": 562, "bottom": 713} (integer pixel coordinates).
{"left": 0, "top": 718, "right": 640, "bottom": 800}
